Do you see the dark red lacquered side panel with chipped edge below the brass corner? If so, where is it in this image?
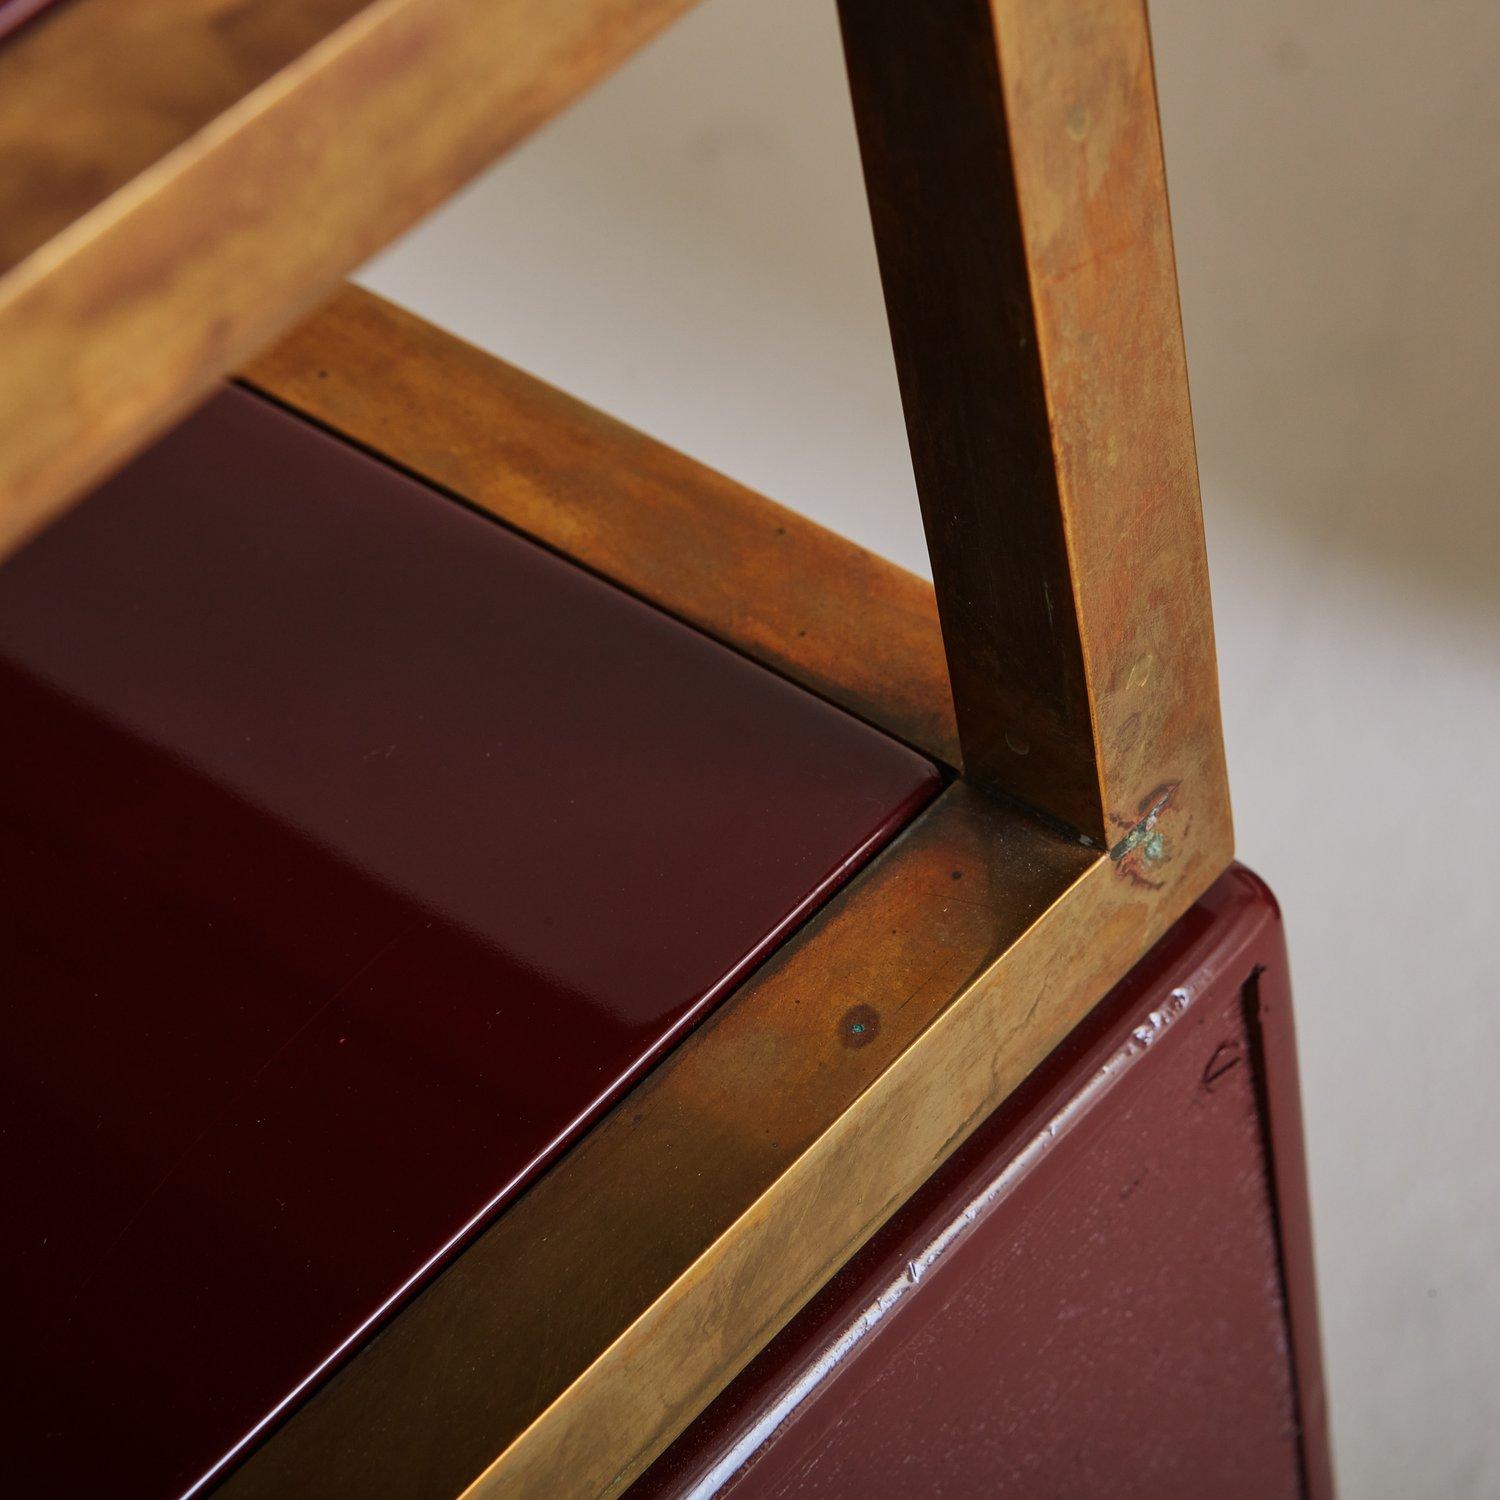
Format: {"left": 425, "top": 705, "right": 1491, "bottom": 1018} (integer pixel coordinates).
{"left": 632, "top": 869, "right": 1332, "bottom": 1500}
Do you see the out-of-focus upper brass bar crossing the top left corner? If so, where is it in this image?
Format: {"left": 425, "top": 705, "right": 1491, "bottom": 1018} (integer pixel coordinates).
{"left": 0, "top": 0, "right": 689, "bottom": 555}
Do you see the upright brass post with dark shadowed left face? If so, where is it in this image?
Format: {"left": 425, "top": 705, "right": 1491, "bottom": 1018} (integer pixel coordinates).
{"left": 840, "top": 0, "right": 1227, "bottom": 848}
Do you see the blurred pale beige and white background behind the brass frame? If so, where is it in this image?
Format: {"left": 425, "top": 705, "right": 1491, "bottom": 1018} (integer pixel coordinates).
{"left": 360, "top": 0, "right": 1500, "bottom": 1497}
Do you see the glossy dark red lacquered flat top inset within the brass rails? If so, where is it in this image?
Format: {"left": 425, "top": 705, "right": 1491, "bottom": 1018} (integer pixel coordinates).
{"left": 0, "top": 392, "right": 938, "bottom": 1496}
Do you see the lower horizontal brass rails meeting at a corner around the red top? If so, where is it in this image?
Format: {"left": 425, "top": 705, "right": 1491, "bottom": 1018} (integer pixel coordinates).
{"left": 225, "top": 72, "right": 1230, "bottom": 1476}
